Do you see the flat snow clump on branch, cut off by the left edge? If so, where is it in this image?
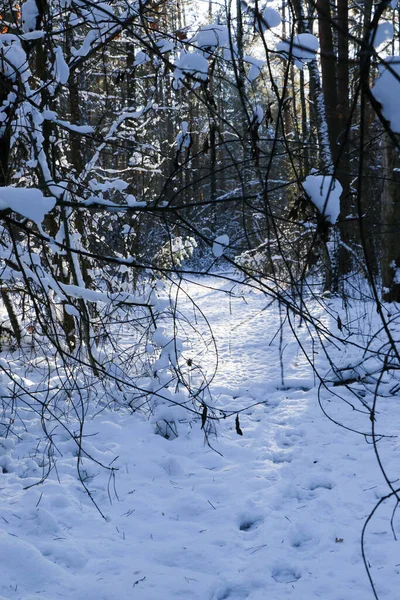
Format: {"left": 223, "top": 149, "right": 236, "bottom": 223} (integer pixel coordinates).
{"left": 0, "top": 186, "right": 56, "bottom": 225}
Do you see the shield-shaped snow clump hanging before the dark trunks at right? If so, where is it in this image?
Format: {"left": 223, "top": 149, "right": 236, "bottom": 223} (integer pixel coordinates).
{"left": 301, "top": 175, "right": 343, "bottom": 225}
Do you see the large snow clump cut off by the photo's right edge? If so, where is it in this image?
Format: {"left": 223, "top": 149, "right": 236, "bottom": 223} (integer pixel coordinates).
{"left": 371, "top": 56, "right": 400, "bottom": 133}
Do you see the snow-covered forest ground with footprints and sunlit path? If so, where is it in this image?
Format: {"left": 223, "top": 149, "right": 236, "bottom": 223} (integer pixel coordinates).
{"left": 0, "top": 277, "right": 400, "bottom": 600}
